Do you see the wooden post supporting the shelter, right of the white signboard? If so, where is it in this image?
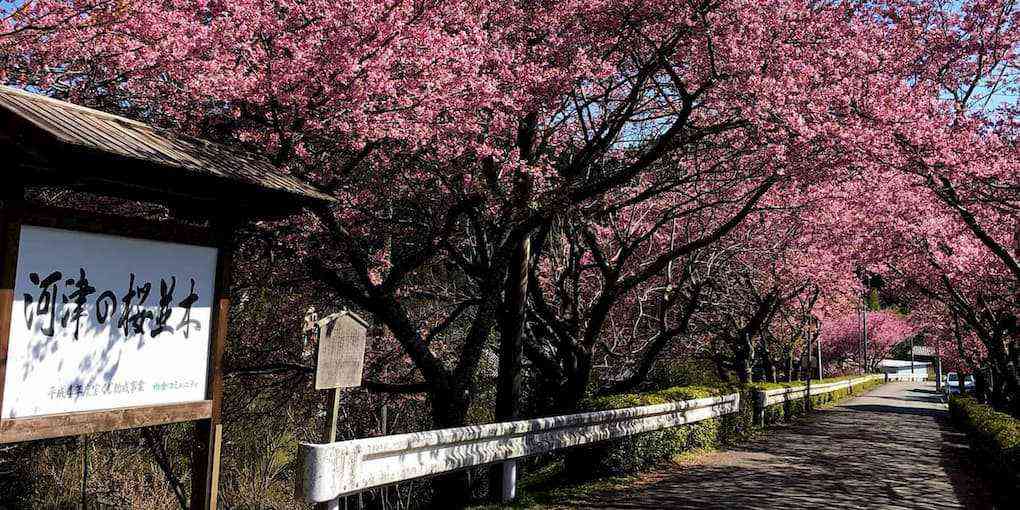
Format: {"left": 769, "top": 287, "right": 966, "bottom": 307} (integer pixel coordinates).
{"left": 191, "top": 221, "right": 234, "bottom": 510}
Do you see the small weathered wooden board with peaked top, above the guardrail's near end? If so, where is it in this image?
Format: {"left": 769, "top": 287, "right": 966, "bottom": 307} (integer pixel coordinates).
{"left": 315, "top": 311, "right": 368, "bottom": 390}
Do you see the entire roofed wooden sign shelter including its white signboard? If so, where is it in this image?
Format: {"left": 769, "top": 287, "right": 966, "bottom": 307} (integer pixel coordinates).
{"left": 0, "top": 88, "right": 333, "bottom": 509}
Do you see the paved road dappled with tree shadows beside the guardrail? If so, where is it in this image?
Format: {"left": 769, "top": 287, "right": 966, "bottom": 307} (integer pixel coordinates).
{"left": 558, "top": 383, "right": 1002, "bottom": 510}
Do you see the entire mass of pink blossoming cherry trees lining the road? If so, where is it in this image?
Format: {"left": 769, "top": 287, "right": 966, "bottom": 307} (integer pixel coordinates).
{"left": 0, "top": 0, "right": 1020, "bottom": 505}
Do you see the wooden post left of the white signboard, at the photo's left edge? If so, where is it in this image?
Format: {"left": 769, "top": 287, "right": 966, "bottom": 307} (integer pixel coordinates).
{"left": 0, "top": 183, "right": 24, "bottom": 418}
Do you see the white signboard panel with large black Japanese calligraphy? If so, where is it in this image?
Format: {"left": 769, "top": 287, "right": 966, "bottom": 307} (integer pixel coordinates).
{"left": 2, "top": 225, "right": 216, "bottom": 418}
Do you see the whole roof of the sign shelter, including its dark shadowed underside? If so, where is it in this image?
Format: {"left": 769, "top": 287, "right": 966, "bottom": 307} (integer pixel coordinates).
{"left": 0, "top": 87, "right": 334, "bottom": 215}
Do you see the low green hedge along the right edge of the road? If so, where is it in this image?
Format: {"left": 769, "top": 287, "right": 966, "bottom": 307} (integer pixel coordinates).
{"left": 950, "top": 395, "right": 1020, "bottom": 496}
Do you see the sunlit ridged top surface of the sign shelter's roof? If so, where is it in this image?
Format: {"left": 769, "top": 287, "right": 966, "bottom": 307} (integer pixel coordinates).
{"left": 0, "top": 87, "right": 334, "bottom": 201}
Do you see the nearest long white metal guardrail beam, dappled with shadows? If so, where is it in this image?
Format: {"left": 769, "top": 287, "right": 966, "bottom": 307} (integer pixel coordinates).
{"left": 298, "top": 394, "right": 741, "bottom": 503}
